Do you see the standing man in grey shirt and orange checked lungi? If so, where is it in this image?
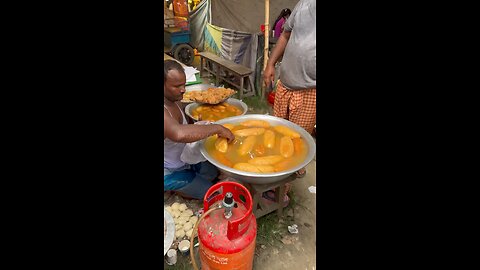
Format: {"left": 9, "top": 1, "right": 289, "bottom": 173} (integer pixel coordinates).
{"left": 264, "top": 0, "right": 317, "bottom": 202}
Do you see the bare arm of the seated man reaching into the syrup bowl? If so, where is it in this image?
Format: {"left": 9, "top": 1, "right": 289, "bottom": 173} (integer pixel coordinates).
{"left": 163, "top": 109, "right": 235, "bottom": 143}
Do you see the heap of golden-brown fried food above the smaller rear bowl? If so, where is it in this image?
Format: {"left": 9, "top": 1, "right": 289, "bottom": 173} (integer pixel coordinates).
{"left": 182, "top": 87, "right": 236, "bottom": 105}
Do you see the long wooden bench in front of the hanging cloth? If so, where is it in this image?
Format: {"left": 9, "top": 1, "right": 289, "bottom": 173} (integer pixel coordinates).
{"left": 199, "top": 52, "right": 255, "bottom": 99}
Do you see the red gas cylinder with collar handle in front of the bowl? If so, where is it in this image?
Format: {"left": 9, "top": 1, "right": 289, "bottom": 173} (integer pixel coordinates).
{"left": 198, "top": 182, "right": 257, "bottom": 270}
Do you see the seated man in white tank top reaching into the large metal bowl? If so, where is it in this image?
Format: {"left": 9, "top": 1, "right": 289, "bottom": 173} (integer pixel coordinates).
{"left": 163, "top": 60, "right": 235, "bottom": 200}
